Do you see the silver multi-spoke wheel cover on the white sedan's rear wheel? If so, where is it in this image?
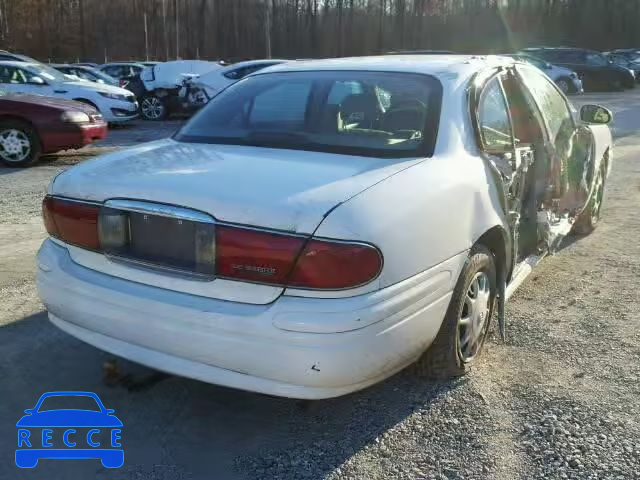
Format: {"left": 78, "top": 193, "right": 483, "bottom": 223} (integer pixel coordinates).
{"left": 457, "top": 271, "right": 491, "bottom": 363}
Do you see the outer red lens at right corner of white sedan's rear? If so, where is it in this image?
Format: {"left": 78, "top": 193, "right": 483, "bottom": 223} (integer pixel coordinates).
{"left": 288, "top": 239, "right": 382, "bottom": 290}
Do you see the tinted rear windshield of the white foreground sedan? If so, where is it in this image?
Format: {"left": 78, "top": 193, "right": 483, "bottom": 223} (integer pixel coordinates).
{"left": 174, "top": 71, "right": 442, "bottom": 157}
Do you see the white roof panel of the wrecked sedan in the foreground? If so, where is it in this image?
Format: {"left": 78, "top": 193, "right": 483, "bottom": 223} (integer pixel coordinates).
{"left": 256, "top": 54, "right": 514, "bottom": 77}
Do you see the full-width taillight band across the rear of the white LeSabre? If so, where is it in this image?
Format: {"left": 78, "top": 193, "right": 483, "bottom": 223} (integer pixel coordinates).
{"left": 42, "top": 196, "right": 382, "bottom": 290}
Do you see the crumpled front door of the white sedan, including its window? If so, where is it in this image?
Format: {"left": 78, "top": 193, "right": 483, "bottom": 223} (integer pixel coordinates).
{"left": 516, "top": 65, "right": 595, "bottom": 219}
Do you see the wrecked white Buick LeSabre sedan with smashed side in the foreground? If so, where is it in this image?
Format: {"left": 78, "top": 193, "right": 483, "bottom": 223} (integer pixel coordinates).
{"left": 37, "top": 55, "right": 612, "bottom": 399}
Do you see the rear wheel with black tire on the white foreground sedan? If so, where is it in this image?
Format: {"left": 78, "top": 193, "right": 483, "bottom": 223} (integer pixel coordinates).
{"left": 416, "top": 245, "right": 497, "bottom": 378}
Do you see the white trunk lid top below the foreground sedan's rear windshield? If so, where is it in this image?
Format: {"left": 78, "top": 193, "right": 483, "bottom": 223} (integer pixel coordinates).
{"left": 50, "top": 139, "right": 421, "bottom": 234}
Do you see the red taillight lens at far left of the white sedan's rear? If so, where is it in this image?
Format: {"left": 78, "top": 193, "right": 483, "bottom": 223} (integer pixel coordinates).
{"left": 42, "top": 197, "right": 100, "bottom": 250}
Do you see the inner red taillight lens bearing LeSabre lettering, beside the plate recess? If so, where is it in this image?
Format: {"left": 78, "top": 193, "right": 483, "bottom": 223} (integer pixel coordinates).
{"left": 216, "top": 225, "right": 306, "bottom": 285}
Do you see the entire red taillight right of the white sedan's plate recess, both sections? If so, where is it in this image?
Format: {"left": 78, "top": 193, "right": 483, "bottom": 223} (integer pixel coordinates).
{"left": 216, "top": 226, "right": 382, "bottom": 290}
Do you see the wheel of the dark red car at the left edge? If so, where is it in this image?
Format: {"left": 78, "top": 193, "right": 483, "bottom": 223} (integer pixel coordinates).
{"left": 0, "top": 120, "right": 41, "bottom": 168}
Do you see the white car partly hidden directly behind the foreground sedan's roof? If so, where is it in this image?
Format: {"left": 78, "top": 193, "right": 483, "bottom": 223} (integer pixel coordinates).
{"left": 180, "top": 59, "right": 287, "bottom": 109}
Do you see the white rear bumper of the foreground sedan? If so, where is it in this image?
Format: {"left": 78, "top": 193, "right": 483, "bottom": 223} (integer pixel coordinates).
{"left": 37, "top": 240, "right": 457, "bottom": 399}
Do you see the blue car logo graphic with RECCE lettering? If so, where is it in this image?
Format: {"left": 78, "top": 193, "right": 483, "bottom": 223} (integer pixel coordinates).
{"left": 16, "top": 391, "right": 124, "bottom": 468}
